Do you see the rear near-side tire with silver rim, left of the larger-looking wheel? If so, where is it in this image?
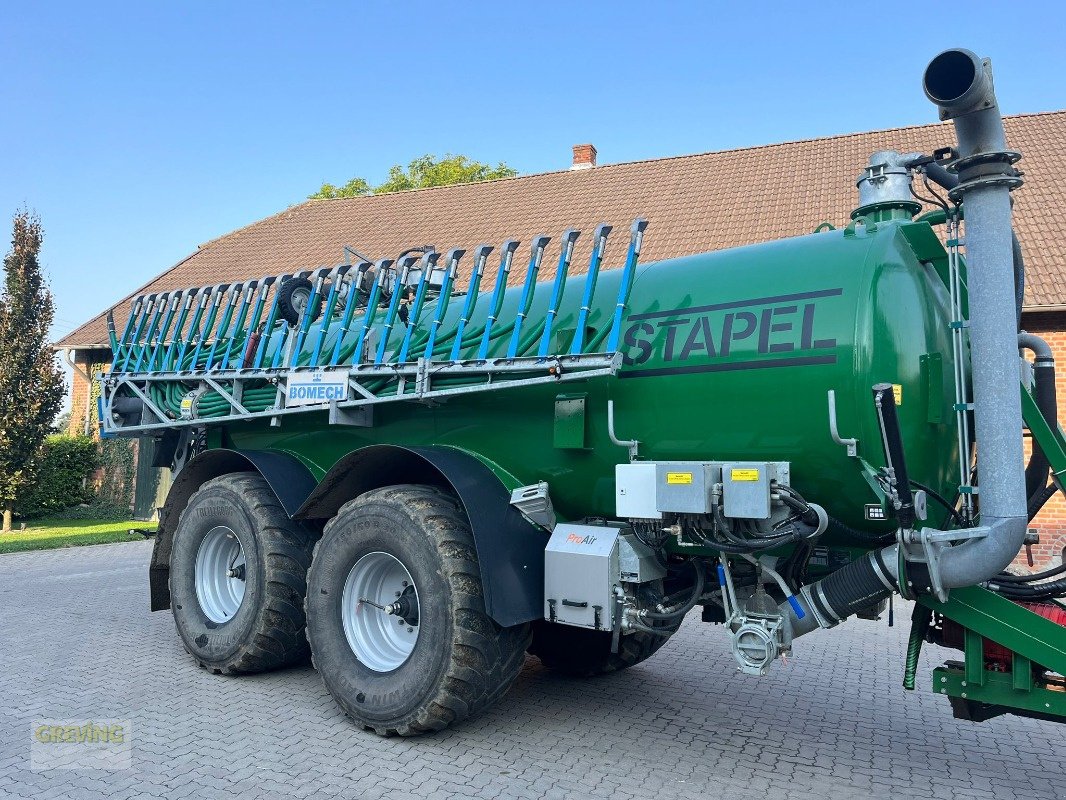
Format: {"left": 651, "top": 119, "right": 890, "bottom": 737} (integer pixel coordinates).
{"left": 171, "top": 473, "right": 314, "bottom": 674}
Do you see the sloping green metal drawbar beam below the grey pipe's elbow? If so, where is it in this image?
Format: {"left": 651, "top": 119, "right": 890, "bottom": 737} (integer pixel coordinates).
{"left": 918, "top": 586, "right": 1066, "bottom": 679}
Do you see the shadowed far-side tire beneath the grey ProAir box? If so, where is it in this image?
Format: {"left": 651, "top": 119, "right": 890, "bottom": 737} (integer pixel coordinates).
{"left": 529, "top": 621, "right": 667, "bottom": 677}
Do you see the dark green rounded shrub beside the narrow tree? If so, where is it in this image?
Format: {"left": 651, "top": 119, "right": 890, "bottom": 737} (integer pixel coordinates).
{"left": 15, "top": 433, "right": 100, "bottom": 517}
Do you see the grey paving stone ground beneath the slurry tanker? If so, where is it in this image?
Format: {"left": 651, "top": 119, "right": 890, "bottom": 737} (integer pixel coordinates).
{"left": 0, "top": 542, "right": 1066, "bottom": 800}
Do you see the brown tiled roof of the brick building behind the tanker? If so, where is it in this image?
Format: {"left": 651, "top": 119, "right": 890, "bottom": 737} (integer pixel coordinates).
{"left": 58, "top": 111, "right": 1066, "bottom": 348}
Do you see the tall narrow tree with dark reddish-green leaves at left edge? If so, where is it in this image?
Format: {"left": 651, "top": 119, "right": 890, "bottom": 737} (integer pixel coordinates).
{"left": 0, "top": 211, "right": 63, "bottom": 530}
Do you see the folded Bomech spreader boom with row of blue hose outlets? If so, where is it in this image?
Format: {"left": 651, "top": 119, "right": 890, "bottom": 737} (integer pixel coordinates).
{"left": 98, "top": 219, "right": 647, "bottom": 435}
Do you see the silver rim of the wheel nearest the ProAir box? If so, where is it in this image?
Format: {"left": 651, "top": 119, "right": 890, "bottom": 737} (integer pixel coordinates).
{"left": 340, "top": 553, "right": 419, "bottom": 672}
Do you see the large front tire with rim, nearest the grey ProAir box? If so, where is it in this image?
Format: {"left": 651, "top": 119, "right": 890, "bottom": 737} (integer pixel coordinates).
{"left": 307, "top": 485, "right": 530, "bottom": 736}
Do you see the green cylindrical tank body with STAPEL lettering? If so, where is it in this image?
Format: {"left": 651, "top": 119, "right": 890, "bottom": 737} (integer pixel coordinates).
{"left": 205, "top": 222, "right": 957, "bottom": 533}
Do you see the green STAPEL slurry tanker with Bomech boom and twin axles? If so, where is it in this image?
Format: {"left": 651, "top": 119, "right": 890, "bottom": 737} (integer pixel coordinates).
{"left": 98, "top": 50, "right": 1066, "bottom": 735}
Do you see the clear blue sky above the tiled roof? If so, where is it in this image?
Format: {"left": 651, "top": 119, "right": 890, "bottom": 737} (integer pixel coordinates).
{"left": 0, "top": 0, "right": 1066, "bottom": 362}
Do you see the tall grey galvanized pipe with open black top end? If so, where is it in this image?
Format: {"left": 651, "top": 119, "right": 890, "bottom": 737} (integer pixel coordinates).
{"left": 923, "top": 49, "right": 1028, "bottom": 588}
